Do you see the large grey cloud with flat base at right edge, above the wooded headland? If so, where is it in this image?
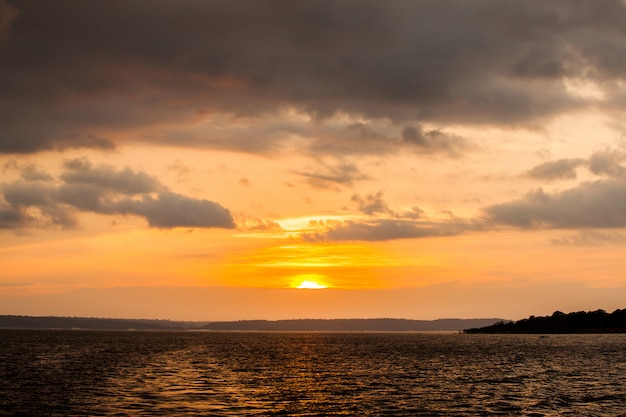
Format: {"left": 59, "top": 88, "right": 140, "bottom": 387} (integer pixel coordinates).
{"left": 484, "top": 177, "right": 626, "bottom": 228}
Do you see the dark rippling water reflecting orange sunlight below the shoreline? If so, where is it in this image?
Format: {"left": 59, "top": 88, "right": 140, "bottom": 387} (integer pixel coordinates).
{"left": 0, "top": 330, "right": 626, "bottom": 416}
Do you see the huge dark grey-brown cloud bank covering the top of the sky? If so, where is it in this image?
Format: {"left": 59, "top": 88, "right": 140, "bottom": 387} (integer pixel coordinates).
{"left": 0, "top": 0, "right": 626, "bottom": 153}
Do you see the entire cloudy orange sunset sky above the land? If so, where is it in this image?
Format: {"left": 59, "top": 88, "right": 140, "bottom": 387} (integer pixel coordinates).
{"left": 0, "top": 0, "right": 626, "bottom": 321}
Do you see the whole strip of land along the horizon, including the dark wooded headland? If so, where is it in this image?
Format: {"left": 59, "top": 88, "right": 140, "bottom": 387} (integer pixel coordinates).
{"left": 6, "top": 309, "right": 626, "bottom": 334}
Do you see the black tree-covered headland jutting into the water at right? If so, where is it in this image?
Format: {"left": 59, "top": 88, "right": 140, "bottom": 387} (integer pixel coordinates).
{"left": 464, "top": 309, "right": 626, "bottom": 334}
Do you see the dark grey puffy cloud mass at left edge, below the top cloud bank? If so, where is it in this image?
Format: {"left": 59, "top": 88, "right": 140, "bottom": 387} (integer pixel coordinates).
{"left": 0, "top": 159, "right": 235, "bottom": 230}
